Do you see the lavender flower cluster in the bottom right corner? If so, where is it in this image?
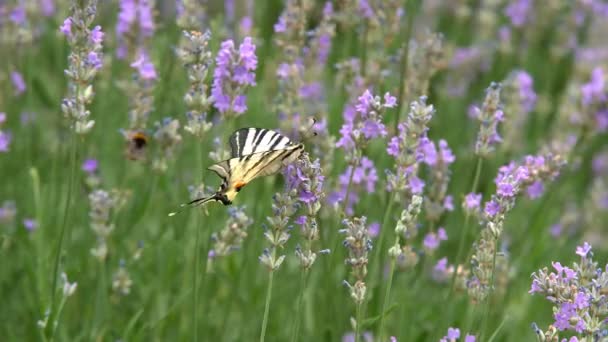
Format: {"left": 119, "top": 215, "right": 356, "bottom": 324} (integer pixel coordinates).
{"left": 529, "top": 242, "right": 608, "bottom": 341}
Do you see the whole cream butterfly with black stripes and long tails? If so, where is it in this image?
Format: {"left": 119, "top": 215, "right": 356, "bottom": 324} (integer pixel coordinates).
{"left": 169, "top": 128, "right": 304, "bottom": 216}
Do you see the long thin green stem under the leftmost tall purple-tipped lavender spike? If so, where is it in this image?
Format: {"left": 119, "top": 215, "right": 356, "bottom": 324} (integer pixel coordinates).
{"left": 48, "top": 132, "right": 77, "bottom": 340}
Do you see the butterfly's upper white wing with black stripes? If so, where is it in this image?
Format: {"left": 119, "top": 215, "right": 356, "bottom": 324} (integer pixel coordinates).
{"left": 229, "top": 128, "right": 294, "bottom": 158}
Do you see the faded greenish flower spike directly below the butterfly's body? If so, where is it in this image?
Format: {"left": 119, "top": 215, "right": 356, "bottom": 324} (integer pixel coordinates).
{"left": 211, "top": 206, "right": 253, "bottom": 256}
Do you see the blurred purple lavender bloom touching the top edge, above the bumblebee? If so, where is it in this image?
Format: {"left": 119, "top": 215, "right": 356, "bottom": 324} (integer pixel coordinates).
{"left": 116, "top": 0, "right": 155, "bottom": 59}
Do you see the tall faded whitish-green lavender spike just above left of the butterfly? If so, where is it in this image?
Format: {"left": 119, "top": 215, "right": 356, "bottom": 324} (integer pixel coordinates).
{"left": 177, "top": 31, "right": 213, "bottom": 139}
